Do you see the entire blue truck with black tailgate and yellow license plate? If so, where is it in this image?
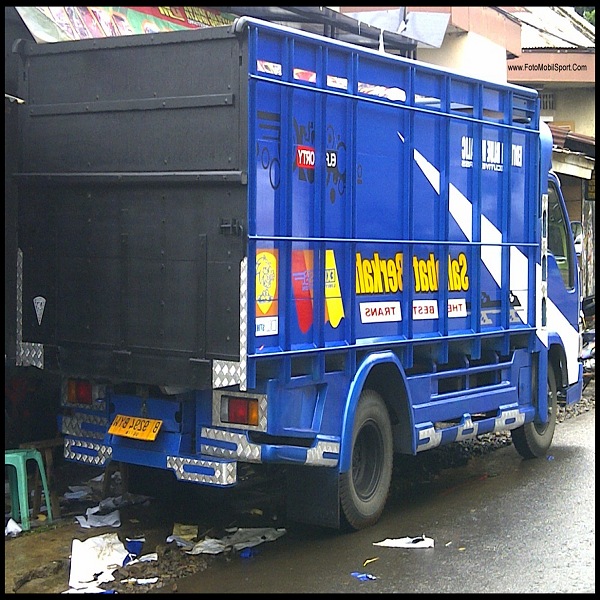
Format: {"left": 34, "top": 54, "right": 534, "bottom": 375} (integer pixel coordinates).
{"left": 15, "top": 18, "right": 582, "bottom": 530}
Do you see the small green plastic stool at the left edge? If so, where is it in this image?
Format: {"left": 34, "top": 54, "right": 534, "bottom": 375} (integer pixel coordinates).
{"left": 4, "top": 448, "right": 53, "bottom": 531}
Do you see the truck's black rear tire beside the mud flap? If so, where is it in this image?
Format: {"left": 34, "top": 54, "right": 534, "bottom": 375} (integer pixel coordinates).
{"left": 340, "top": 390, "right": 394, "bottom": 530}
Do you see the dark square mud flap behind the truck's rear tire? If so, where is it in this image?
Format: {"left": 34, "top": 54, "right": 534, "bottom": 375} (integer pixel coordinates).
{"left": 286, "top": 466, "right": 340, "bottom": 529}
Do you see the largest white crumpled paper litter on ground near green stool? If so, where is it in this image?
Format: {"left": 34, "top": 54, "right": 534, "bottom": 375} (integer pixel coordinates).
{"left": 69, "top": 533, "right": 129, "bottom": 590}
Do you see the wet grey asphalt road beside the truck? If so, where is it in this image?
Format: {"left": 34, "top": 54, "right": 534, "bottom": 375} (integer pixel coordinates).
{"left": 170, "top": 410, "right": 596, "bottom": 593}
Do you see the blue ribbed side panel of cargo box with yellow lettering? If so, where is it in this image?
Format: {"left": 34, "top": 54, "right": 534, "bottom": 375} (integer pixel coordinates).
{"left": 248, "top": 19, "right": 540, "bottom": 361}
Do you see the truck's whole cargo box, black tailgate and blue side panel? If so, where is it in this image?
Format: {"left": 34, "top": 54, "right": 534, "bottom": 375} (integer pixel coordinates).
{"left": 15, "top": 21, "right": 538, "bottom": 387}
